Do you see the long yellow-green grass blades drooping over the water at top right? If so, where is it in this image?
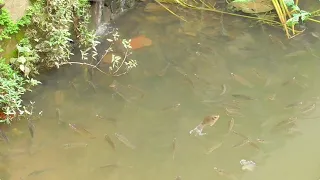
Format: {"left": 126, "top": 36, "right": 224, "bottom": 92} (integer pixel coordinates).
{"left": 156, "top": 0, "right": 320, "bottom": 38}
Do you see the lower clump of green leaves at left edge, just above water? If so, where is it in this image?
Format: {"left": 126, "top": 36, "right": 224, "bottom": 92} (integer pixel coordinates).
{"left": 0, "top": 58, "right": 40, "bottom": 123}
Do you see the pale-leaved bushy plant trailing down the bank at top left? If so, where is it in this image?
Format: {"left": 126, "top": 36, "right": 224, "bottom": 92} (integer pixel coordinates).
{"left": 26, "top": 0, "right": 98, "bottom": 68}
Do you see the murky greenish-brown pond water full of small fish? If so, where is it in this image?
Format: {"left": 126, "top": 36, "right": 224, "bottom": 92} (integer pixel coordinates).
{"left": 0, "top": 2, "right": 320, "bottom": 180}
